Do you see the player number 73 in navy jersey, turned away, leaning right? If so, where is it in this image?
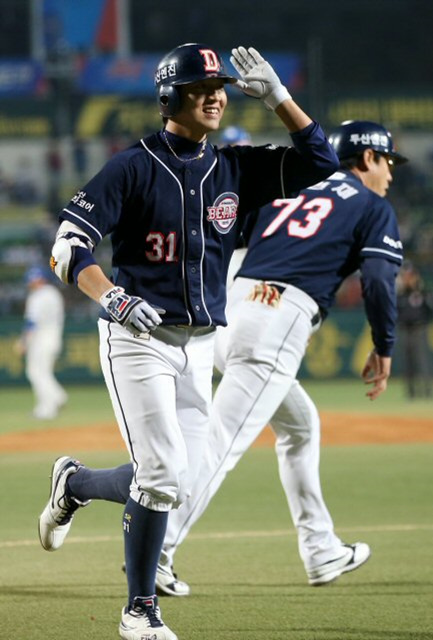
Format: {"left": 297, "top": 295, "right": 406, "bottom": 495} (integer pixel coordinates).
{"left": 155, "top": 121, "right": 406, "bottom": 595}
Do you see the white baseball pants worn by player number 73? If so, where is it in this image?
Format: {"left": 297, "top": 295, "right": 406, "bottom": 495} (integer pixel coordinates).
{"left": 162, "top": 278, "right": 341, "bottom": 569}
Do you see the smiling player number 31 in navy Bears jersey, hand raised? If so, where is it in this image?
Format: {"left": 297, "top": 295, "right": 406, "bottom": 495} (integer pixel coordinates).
{"left": 39, "top": 44, "right": 338, "bottom": 640}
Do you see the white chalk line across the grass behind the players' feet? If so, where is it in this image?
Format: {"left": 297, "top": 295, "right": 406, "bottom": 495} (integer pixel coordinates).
{"left": 0, "top": 523, "right": 433, "bottom": 549}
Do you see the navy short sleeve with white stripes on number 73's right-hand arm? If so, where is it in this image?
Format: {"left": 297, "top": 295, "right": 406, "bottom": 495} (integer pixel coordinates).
{"left": 358, "top": 194, "right": 403, "bottom": 265}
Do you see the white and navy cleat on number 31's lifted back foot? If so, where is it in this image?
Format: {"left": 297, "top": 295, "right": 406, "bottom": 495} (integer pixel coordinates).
{"left": 39, "top": 456, "right": 90, "bottom": 551}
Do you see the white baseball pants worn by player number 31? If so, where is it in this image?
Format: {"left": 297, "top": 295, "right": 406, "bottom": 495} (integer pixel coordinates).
{"left": 98, "top": 320, "right": 215, "bottom": 511}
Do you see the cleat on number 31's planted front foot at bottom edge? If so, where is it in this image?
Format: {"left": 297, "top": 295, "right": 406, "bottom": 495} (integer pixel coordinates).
{"left": 119, "top": 596, "right": 177, "bottom": 640}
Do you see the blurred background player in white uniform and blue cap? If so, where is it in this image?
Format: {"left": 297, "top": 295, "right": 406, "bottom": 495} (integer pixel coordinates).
{"left": 18, "top": 267, "right": 68, "bottom": 420}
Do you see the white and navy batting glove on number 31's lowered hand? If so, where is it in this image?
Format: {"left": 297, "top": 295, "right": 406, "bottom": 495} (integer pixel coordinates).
{"left": 99, "top": 287, "right": 165, "bottom": 336}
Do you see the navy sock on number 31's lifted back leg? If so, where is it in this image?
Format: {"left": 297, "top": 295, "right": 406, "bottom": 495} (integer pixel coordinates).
{"left": 66, "top": 463, "right": 132, "bottom": 504}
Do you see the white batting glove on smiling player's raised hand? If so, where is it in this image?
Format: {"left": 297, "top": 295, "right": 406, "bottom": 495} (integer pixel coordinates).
{"left": 230, "top": 47, "right": 292, "bottom": 109}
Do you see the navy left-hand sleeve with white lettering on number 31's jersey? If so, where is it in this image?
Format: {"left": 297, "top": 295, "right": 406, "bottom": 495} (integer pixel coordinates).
{"left": 60, "top": 154, "right": 131, "bottom": 244}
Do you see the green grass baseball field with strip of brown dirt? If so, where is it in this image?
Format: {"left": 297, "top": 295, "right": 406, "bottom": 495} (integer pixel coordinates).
{"left": 0, "top": 380, "right": 433, "bottom": 640}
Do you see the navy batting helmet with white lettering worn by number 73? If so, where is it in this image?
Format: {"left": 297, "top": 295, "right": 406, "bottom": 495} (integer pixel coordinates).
{"left": 329, "top": 120, "right": 407, "bottom": 164}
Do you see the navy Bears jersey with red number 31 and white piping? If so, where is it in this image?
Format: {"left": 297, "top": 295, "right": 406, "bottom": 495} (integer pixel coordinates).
{"left": 60, "top": 123, "right": 338, "bottom": 326}
